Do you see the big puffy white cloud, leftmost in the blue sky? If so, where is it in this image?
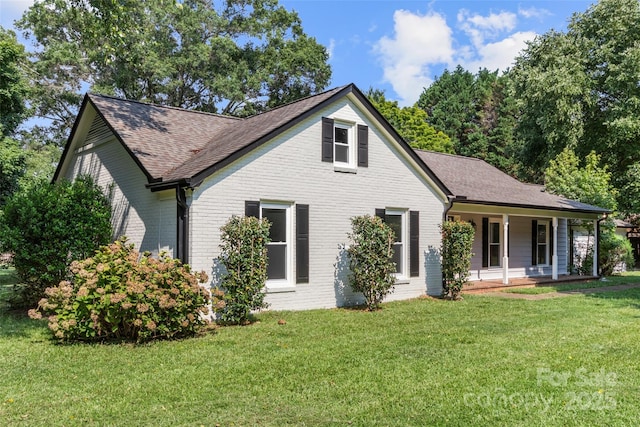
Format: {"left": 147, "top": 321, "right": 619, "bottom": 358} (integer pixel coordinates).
{"left": 374, "top": 10, "right": 454, "bottom": 105}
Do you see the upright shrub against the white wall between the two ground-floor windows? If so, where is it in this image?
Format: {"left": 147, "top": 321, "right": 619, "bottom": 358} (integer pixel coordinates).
{"left": 347, "top": 215, "right": 396, "bottom": 311}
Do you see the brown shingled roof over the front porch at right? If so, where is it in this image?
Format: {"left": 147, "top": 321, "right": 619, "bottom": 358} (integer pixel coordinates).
{"left": 416, "top": 150, "right": 608, "bottom": 213}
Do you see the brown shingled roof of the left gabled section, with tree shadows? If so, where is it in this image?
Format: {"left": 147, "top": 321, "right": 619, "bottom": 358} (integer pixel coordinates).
{"left": 79, "top": 85, "right": 353, "bottom": 187}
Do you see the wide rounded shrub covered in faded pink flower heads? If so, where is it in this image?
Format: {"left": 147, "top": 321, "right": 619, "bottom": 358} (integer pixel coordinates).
{"left": 29, "top": 238, "right": 220, "bottom": 342}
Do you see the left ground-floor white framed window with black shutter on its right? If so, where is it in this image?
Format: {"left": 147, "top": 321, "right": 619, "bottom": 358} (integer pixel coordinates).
{"left": 260, "top": 203, "right": 292, "bottom": 286}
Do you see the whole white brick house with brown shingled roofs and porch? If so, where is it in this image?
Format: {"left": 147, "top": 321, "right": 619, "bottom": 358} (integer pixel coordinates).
{"left": 54, "top": 84, "right": 604, "bottom": 309}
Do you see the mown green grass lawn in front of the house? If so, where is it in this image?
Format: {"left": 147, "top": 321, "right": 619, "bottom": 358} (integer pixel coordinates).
{"left": 0, "top": 273, "right": 640, "bottom": 426}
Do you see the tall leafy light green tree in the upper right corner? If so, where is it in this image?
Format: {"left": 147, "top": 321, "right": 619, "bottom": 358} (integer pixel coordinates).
{"left": 512, "top": 0, "right": 640, "bottom": 194}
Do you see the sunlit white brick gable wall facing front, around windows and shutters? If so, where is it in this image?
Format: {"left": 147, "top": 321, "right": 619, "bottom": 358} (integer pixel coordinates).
{"left": 190, "top": 99, "right": 444, "bottom": 309}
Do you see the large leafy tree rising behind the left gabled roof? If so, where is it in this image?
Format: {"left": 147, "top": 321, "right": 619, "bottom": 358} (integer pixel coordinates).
{"left": 17, "top": 0, "right": 331, "bottom": 144}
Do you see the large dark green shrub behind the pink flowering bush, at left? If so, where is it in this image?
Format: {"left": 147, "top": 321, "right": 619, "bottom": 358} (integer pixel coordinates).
{"left": 0, "top": 177, "right": 112, "bottom": 307}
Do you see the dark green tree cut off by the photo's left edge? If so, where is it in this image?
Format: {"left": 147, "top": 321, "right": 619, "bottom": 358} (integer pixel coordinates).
{"left": 0, "top": 27, "right": 29, "bottom": 206}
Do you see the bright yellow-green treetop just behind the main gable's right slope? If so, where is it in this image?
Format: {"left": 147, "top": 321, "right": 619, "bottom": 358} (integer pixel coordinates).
{"left": 366, "top": 88, "right": 453, "bottom": 153}
